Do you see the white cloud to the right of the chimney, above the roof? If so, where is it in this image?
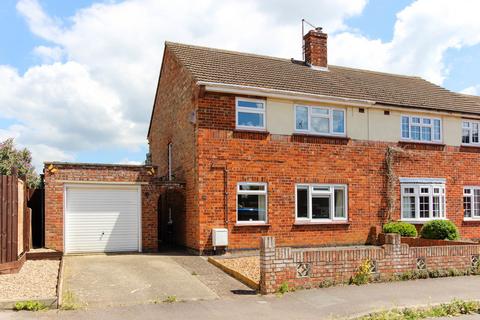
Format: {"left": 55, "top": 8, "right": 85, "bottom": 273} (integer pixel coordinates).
{"left": 330, "top": 0, "right": 480, "bottom": 84}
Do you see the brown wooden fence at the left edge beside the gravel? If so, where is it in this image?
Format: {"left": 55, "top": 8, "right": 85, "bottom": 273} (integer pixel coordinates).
{"left": 0, "top": 175, "right": 30, "bottom": 274}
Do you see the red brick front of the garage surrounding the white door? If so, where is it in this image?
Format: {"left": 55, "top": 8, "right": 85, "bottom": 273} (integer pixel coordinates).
{"left": 44, "top": 163, "right": 159, "bottom": 252}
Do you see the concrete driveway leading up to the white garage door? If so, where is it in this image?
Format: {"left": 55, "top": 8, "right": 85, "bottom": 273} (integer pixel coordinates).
{"left": 62, "top": 254, "right": 218, "bottom": 307}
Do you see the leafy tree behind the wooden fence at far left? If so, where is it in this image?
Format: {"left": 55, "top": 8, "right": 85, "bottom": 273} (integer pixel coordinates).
{"left": 0, "top": 138, "right": 40, "bottom": 188}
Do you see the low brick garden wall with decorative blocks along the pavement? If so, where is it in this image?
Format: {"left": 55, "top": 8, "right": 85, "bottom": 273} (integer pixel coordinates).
{"left": 260, "top": 234, "right": 480, "bottom": 294}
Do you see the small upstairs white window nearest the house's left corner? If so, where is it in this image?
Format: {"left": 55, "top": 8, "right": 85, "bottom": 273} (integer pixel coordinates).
{"left": 235, "top": 97, "right": 265, "bottom": 131}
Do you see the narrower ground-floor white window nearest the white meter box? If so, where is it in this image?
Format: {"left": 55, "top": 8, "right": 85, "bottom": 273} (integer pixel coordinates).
{"left": 237, "top": 182, "right": 267, "bottom": 224}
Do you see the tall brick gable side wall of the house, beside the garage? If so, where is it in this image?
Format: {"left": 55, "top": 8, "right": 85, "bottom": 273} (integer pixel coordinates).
{"left": 148, "top": 46, "right": 199, "bottom": 248}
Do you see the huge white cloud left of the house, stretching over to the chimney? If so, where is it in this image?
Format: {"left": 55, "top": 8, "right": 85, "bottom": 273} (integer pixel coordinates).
{"left": 0, "top": 0, "right": 367, "bottom": 169}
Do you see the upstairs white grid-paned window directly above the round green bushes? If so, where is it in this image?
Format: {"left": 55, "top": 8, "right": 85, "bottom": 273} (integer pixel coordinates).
{"left": 401, "top": 116, "right": 442, "bottom": 143}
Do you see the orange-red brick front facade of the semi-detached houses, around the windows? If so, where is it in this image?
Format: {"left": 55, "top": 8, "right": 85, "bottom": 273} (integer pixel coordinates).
{"left": 196, "top": 93, "right": 480, "bottom": 250}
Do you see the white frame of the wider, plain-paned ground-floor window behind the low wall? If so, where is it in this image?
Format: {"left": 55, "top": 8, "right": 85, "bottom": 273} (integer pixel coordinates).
{"left": 295, "top": 183, "right": 348, "bottom": 223}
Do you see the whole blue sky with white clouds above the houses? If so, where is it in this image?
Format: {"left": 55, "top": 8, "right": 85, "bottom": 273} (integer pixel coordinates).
{"left": 0, "top": 0, "right": 480, "bottom": 168}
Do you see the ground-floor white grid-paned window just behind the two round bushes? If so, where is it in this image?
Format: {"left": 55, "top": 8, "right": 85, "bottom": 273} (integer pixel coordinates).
{"left": 401, "top": 184, "right": 446, "bottom": 221}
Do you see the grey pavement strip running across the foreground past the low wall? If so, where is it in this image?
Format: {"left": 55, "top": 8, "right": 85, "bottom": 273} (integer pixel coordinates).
{"left": 0, "top": 274, "right": 480, "bottom": 320}
